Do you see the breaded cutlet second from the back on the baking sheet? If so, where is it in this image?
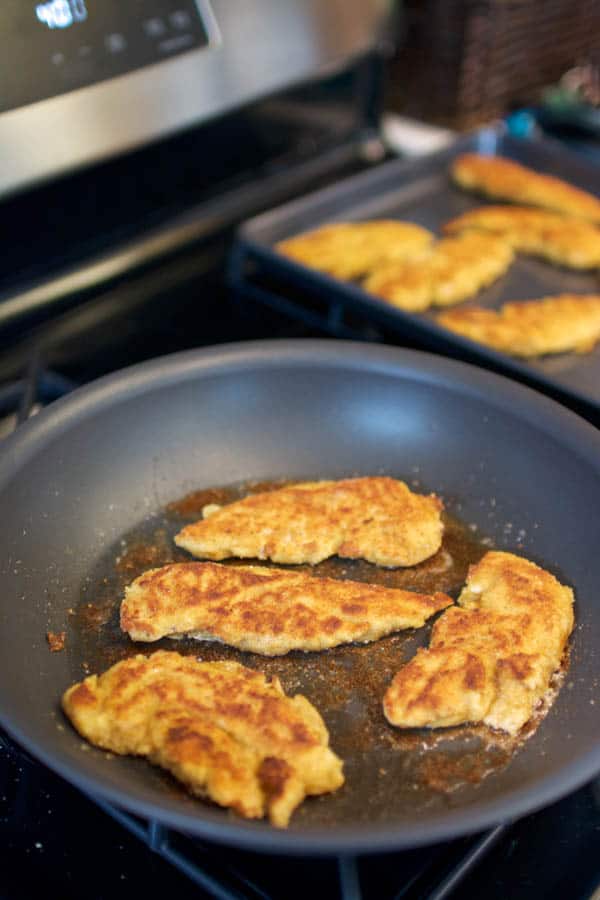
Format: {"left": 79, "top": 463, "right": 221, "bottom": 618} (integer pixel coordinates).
{"left": 444, "top": 206, "right": 600, "bottom": 269}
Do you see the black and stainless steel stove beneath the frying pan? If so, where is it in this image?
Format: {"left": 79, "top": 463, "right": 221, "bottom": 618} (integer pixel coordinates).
{"left": 0, "top": 0, "right": 600, "bottom": 900}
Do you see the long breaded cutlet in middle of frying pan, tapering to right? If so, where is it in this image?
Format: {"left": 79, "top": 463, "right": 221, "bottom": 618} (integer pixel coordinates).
{"left": 121, "top": 562, "right": 452, "bottom": 656}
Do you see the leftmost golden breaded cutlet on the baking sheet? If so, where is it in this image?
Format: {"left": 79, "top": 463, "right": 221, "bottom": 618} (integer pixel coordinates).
{"left": 275, "top": 219, "right": 433, "bottom": 279}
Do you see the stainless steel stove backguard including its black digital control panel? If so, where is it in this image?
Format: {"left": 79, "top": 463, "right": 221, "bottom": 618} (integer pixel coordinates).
{"left": 0, "top": 0, "right": 389, "bottom": 196}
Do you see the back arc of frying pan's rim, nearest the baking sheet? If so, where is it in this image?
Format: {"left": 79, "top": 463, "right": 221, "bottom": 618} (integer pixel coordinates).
{"left": 0, "top": 338, "right": 600, "bottom": 472}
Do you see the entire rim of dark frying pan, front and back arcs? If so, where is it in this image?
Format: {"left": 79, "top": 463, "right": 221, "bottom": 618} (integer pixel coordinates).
{"left": 0, "top": 339, "right": 600, "bottom": 855}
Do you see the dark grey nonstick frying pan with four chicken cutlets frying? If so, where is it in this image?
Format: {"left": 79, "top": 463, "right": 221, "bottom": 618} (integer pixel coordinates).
{"left": 0, "top": 340, "right": 600, "bottom": 853}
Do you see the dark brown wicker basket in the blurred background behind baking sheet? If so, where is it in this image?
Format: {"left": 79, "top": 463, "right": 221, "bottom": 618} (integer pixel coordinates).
{"left": 388, "top": 0, "right": 600, "bottom": 128}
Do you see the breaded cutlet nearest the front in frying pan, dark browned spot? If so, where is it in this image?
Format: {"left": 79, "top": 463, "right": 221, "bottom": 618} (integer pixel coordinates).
{"left": 62, "top": 651, "right": 344, "bottom": 828}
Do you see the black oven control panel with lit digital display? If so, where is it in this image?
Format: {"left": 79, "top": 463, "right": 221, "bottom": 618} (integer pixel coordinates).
{"left": 0, "top": 0, "right": 208, "bottom": 113}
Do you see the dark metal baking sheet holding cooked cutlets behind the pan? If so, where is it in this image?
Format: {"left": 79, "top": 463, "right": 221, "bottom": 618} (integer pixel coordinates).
{"left": 238, "top": 128, "right": 600, "bottom": 409}
